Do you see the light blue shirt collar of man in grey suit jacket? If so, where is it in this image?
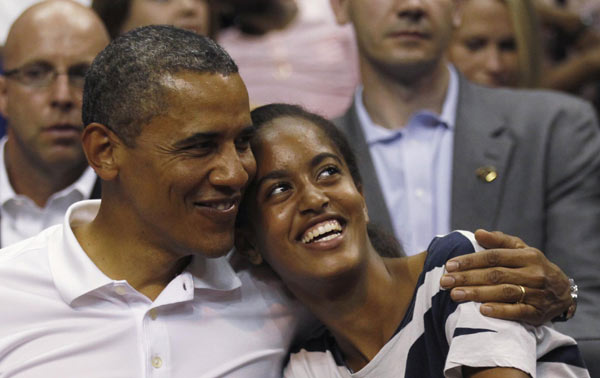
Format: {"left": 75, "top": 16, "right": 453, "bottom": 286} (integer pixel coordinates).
{"left": 354, "top": 64, "right": 459, "bottom": 143}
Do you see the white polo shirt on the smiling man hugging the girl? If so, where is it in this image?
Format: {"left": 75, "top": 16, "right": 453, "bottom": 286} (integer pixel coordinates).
{"left": 0, "top": 200, "right": 306, "bottom": 378}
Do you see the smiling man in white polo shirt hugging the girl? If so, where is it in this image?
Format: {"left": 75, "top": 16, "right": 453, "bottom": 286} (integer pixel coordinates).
{"left": 0, "top": 20, "right": 567, "bottom": 378}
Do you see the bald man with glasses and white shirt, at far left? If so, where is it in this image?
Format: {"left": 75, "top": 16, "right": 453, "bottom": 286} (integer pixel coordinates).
{"left": 0, "top": 0, "right": 109, "bottom": 247}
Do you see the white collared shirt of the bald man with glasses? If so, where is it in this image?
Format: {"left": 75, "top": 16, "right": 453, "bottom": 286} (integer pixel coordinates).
{"left": 0, "top": 136, "right": 97, "bottom": 247}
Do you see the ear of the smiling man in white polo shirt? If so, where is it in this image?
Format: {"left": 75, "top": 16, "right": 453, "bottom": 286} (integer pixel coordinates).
{"left": 81, "top": 123, "right": 124, "bottom": 181}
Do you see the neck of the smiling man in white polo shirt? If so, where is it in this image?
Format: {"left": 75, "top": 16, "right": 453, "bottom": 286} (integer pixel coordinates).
{"left": 73, "top": 198, "right": 191, "bottom": 301}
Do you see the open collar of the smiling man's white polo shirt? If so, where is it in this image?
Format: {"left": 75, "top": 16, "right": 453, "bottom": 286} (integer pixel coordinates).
{"left": 48, "top": 200, "right": 241, "bottom": 304}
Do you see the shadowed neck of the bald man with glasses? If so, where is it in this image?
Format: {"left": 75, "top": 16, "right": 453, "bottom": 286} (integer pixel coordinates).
{"left": 4, "top": 140, "right": 87, "bottom": 208}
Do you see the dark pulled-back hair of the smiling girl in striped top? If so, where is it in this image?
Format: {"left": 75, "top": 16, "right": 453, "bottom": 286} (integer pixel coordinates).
{"left": 246, "top": 104, "right": 404, "bottom": 257}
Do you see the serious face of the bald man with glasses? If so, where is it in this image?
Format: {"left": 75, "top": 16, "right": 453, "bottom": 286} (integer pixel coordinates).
{"left": 0, "top": 18, "right": 108, "bottom": 170}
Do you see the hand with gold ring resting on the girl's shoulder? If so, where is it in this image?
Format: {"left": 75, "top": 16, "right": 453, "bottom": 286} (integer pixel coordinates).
{"left": 440, "top": 230, "right": 575, "bottom": 325}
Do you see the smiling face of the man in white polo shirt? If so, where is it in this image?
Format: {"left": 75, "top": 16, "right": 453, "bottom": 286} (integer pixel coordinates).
{"left": 117, "top": 72, "right": 256, "bottom": 257}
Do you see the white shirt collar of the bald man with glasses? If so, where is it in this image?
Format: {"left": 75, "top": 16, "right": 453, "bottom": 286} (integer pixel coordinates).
{"left": 0, "top": 136, "right": 97, "bottom": 205}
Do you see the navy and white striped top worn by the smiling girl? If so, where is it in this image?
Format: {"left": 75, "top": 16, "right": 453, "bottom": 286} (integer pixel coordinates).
{"left": 284, "top": 231, "right": 589, "bottom": 378}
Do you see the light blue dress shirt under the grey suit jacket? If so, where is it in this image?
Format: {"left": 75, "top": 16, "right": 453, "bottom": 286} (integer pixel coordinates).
{"left": 354, "top": 66, "right": 458, "bottom": 255}
